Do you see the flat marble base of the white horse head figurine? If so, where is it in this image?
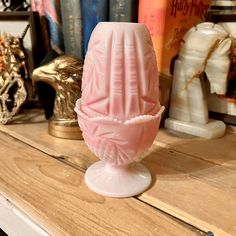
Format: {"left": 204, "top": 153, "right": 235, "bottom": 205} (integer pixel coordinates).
{"left": 165, "top": 118, "right": 226, "bottom": 139}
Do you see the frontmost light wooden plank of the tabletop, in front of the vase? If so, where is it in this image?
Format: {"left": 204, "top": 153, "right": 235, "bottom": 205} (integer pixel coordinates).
{"left": 0, "top": 133, "right": 201, "bottom": 236}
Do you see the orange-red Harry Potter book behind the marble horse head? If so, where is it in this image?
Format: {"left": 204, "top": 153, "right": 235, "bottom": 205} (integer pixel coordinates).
{"left": 138, "top": 0, "right": 211, "bottom": 76}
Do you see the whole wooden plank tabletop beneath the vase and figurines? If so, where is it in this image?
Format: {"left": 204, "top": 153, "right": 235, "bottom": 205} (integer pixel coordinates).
{"left": 0, "top": 110, "right": 236, "bottom": 236}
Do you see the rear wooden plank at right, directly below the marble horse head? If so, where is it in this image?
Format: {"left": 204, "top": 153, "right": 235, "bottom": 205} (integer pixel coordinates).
{"left": 155, "top": 127, "right": 236, "bottom": 169}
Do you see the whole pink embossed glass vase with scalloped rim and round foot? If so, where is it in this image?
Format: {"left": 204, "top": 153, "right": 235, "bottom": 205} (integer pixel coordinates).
{"left": 75, "top": 22, "right": 164, "bottom": 197}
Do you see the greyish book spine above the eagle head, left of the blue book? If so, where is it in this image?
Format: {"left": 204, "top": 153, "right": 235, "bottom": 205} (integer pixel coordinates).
{"left": 61, "top": 0, "right": 83, "bottom": 59}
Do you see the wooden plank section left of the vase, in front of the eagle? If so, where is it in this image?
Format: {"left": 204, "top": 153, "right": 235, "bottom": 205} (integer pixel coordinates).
{"left": 0, "top": 109, "right": 97, "bottom": 170}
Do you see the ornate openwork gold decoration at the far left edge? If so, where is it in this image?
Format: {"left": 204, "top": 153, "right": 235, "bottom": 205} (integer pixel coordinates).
{"left": 0, "top": 34, "right": 28, "bottom": 124}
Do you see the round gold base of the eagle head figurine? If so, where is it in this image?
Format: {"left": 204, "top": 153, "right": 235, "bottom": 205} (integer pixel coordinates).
{"left": 48, "top": 120, "right": 83, "bottom": 139}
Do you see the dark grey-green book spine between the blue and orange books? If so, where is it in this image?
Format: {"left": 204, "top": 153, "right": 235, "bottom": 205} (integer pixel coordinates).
{"left": 109, "top": 0, "right": 138, "bottom": 22}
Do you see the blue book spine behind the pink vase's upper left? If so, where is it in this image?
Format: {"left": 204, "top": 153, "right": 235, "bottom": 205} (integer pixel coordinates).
{"left": 81, "top": 0, "right": 109, "bottom": 56}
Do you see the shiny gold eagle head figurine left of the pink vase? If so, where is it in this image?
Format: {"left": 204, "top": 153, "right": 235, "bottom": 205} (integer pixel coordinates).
{"left": 32, "top": 55, "right": 83, "bottom": 139}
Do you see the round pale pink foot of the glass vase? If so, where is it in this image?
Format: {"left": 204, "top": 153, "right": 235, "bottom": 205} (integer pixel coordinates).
{"left": 85, "top": 161, "right": 151, "bottom": 198}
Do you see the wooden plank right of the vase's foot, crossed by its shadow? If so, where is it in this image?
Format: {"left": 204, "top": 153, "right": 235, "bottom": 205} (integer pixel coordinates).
{"left": 140, "top": 148, "right": 236, "bottom": 236}
